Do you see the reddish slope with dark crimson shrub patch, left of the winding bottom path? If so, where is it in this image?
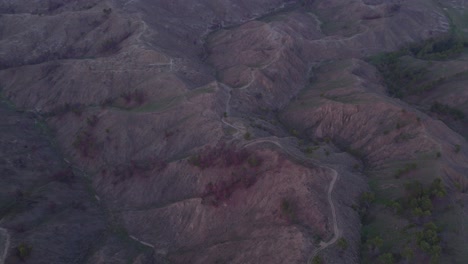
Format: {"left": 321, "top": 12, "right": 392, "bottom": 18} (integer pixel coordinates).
{"left": 116, "top": 150, "right": 330, "bottom": 263}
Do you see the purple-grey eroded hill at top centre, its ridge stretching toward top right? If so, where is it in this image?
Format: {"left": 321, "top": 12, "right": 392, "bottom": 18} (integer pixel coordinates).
{"left": 207, "top": 1, "right": 448, "bottom": 111}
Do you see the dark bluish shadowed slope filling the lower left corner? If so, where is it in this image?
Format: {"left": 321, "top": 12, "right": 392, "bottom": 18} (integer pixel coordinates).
{"left": 0, "top": 101, "right": 159, "bottom": 264}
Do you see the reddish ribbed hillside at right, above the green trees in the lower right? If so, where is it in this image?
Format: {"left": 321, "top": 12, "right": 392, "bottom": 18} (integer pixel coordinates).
{"left": 280, "top": 60, "right": 468, "bottom": 263}
